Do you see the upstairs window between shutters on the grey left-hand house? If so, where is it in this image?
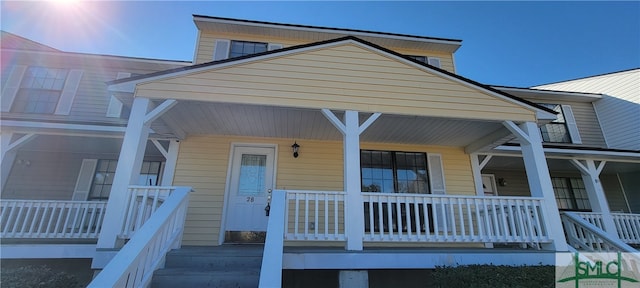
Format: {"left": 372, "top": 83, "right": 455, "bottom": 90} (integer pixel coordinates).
{"left": 11, "top": 67, "right": 68, "bottom": 114}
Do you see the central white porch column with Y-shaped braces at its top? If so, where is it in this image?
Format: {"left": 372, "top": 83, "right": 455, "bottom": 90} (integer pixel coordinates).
{"left": 322, "top": 109, "right": 381, "bottom": 250}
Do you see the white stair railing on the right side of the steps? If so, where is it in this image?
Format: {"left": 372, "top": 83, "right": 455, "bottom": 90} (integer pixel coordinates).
{"left": 258, "top": 190, "right": 284, "bottom": 288}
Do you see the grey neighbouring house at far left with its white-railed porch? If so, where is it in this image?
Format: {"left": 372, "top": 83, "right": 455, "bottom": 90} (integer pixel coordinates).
{"left": 0, "top": 31, "right": 190, "bottom": 258}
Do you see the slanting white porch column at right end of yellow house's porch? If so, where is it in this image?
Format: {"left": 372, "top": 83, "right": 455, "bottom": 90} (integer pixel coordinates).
{"left": 503, "top": 121, "right": 568, "bottom": 251}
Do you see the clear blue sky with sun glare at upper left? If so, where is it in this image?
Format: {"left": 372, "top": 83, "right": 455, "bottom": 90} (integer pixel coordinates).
{"left": 0, "top": 0, "right": 640, "bottom": 87}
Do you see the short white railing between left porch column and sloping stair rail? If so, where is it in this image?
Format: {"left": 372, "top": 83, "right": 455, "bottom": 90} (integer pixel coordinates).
{"left": 120, "top": 186, "right": 176, "bottom": 239}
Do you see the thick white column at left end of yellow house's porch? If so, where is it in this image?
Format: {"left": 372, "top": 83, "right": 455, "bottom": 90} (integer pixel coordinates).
{"left": 92, "top": 97, "right": 151, "bottom": 269}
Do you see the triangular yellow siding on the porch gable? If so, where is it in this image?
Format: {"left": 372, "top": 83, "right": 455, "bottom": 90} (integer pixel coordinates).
{"left": 136, "top": 44, "right": 535, "bottom": 121}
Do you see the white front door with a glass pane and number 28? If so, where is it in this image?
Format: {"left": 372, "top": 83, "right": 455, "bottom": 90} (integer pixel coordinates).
{"left": 225, "top": 146, "right": 275, "bottom": 232}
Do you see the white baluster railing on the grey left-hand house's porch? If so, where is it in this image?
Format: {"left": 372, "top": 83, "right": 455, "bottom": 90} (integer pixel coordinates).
{"left": 0, "top": 199, "right": 107, "bottom": 239}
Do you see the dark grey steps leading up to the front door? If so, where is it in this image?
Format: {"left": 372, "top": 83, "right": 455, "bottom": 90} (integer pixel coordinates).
{"left": 151, "top": 245, "right": 264, "bottom": 288}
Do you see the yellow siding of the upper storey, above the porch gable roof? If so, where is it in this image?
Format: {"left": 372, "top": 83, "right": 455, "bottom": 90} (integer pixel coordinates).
{"left": 195, "top": 31, "right": 455, "bottom": 73}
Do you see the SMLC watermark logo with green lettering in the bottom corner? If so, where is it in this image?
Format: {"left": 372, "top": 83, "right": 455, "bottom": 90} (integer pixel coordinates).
{"left": 556, "top": 252, "right": 640, "bottom": 288}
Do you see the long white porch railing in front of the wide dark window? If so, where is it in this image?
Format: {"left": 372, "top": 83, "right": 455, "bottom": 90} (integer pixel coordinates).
{"left": 362, "top": 193, "right": 551, "bottom": 247}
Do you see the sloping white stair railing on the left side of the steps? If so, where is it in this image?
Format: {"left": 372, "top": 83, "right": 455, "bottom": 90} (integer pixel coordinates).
{"left": 88, "top": 187, "right": 191, "bottom": 287}
